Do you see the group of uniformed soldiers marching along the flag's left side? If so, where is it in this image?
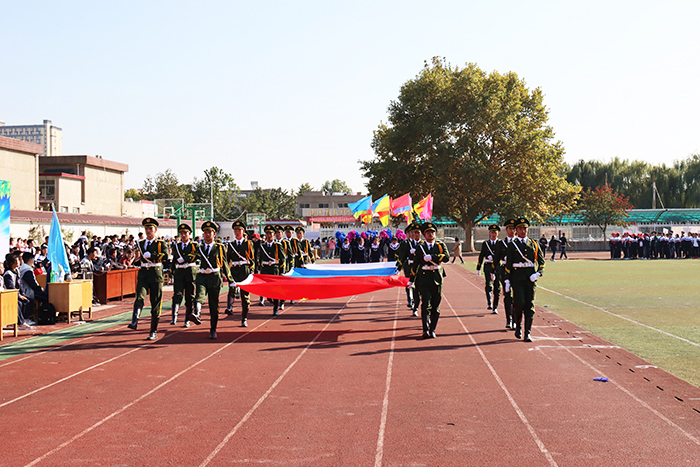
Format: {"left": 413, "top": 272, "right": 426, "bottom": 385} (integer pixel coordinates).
{"left": 128, "top": 217, "right": 314, "bottom": 340}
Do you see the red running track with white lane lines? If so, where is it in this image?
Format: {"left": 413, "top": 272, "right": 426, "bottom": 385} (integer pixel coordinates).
{"left": 0, "top": 265, "right": 700, "bottom": 466}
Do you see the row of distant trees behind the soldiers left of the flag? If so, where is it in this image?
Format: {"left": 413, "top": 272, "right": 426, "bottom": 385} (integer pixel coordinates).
{"left": 124, "top": 167, "right": 351, "bottom": 220}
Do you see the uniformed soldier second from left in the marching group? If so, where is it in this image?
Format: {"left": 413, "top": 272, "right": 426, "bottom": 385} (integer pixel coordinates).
{"left": 170, "top": 224, "right": 198, "bottom": 327}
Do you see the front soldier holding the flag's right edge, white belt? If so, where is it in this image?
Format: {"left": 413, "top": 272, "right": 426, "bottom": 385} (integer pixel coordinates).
{"left": 415, "top": 222, "right": 450, "bottom": 339}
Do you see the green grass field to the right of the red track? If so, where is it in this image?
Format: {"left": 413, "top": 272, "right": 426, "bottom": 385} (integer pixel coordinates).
{"left": 471, "top": 260, "right": 700, "bottom": 386}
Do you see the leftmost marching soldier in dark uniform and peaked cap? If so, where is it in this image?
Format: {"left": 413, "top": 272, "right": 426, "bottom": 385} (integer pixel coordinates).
{"left": 128, "top": 217, "right": 169, "bottom": 341}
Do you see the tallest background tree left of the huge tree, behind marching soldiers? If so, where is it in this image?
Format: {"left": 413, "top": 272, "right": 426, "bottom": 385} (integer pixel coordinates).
{"left": 192, "top": 167, "right": 240, "bottom": 221}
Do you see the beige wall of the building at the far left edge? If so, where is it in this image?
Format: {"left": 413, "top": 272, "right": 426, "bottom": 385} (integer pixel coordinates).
{"left": 0, "top": 138, "right": 41, "bottom": 209}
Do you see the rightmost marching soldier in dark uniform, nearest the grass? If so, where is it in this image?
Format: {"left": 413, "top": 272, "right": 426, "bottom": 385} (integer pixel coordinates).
{"left": 505, "top": 217, "right": 544, "bottom": 342}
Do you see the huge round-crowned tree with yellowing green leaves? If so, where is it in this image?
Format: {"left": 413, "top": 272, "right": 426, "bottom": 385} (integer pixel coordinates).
{"left": 362, "top": 58, "right": 579, "bottom": 250}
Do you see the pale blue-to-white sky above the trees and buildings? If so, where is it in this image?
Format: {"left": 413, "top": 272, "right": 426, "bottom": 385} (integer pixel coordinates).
{"left": 0, "top": 0, "right": 700, "bottom": 192}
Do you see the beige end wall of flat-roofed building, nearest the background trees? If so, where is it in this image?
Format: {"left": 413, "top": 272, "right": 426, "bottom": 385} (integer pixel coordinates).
{"left": 81, "top": 165, "right": 124, "bottom": 216}
